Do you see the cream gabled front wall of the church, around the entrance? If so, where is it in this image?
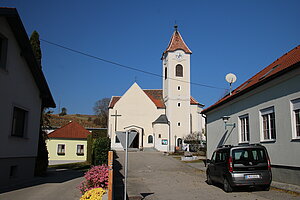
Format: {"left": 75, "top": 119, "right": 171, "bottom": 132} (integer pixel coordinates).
{"left": 109, "top": 83, "right": 165, "bottom": 149}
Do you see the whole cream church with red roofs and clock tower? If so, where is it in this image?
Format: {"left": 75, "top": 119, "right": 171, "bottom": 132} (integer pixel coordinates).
{"left": 108, "top": 26, "right": 204, "bottom": 152}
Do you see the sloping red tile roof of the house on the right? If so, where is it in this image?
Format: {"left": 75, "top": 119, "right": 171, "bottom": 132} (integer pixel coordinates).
{"left": 202, "top": 45, "right": 300, "bottom": 113}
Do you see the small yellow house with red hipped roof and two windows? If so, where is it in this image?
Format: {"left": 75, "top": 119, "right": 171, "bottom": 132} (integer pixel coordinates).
{"left": 47, "top": 121, "right": 90, "bottom": 165}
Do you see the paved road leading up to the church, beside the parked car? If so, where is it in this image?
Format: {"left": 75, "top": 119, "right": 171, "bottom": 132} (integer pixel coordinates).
{"left": 115, "top": 152, "right": 300, "bottom": 200}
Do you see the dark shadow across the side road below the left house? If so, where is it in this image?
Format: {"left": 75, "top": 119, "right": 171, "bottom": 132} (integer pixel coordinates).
{"left": 0, "top": 168, "right": 84, "bottom": 194}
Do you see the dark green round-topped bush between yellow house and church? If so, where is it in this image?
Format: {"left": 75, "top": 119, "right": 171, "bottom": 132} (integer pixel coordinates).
{"left": 93, "top": 137, "right": 110, "bottom": 165}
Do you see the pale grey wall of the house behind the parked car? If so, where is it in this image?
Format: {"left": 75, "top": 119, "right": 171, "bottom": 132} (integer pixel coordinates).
{"left": 207, "top": 68, "right": 300, "bottom": 184}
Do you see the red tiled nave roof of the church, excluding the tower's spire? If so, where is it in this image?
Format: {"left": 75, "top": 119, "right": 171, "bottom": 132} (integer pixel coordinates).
{"left": 108, "top": 89, "right": 204, "bottom": 108}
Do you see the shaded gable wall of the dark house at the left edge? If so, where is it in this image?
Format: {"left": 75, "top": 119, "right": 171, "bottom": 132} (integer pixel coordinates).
{"left": 0, "top": 18, "right": 42, "bottom": 184}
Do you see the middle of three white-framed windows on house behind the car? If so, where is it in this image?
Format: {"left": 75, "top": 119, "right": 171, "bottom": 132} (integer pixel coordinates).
{"left": 260, "top": 107, "right": 276, "bottom": 141}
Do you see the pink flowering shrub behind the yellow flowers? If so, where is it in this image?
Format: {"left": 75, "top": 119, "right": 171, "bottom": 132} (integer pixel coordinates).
{"left": 79, "top": 165, "right": 108, "bottom": 194}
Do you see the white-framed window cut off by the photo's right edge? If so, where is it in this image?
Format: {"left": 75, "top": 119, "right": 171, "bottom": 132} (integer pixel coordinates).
{"left": 291, "top": 98, "right": 300, "bottom": 139}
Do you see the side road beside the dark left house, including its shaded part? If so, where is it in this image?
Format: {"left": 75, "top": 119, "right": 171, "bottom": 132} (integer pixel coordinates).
{"left": 0, "top": 170, "right": 84, "bottom": 200}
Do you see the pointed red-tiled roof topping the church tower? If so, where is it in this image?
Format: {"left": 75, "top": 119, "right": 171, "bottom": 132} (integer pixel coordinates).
{"left": 164, "top": 29, "right": 192, "bottom": 54}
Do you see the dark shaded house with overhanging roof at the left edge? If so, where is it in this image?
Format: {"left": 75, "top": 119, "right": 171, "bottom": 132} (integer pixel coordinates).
{"left": 0, "top": 8, "right": 55, "bottom": 187}
